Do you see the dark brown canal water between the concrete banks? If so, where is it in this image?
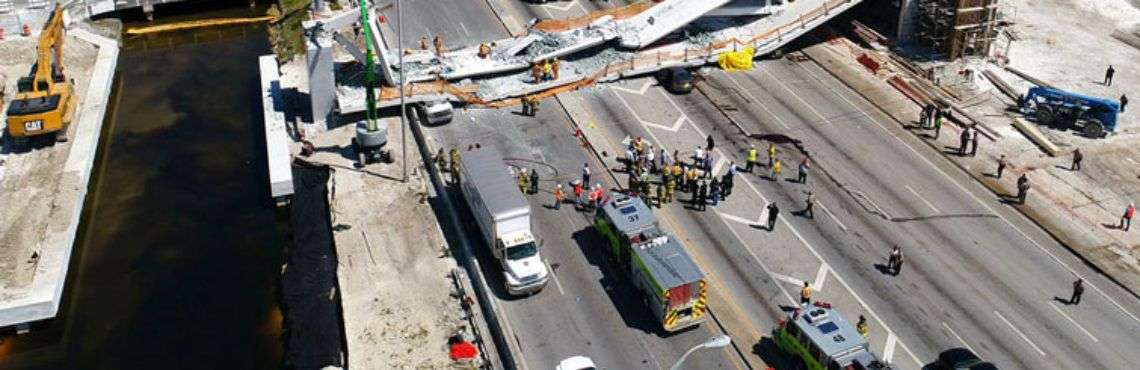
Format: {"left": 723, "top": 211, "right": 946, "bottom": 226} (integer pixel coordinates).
{"left": 0, "top": 8, "right": 290, "bottom": 369}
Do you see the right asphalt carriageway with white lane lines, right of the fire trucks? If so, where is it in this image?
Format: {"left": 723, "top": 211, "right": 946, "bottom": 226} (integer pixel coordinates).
{"left": 565, "top": 55, "right": 1140, "bottom": 369}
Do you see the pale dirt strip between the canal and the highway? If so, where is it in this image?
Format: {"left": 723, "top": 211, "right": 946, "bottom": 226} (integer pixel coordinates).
{"left": 294, "top": 114, "right": 465, "bottom": 369}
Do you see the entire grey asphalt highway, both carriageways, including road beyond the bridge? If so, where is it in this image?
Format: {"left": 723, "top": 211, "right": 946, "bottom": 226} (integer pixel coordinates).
{"left": 388, "top": 0, "right": 1140, "bottom": 369}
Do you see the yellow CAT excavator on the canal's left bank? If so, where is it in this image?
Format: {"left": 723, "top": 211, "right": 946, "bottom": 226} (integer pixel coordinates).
{"left": 8, "top": 5, "right": 75, "bottom": 146}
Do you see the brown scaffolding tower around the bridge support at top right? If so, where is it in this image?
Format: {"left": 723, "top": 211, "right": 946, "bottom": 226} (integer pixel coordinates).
{"left": 917, "top": 0, "right": 1000, "bottom": 60}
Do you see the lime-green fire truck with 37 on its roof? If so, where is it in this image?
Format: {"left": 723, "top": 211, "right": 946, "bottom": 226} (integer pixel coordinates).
{"left": 594, "top": 195, "right": 708, "bottom": 331}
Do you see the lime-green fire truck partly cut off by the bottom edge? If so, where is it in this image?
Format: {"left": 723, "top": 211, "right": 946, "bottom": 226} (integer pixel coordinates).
{"left": 772, "top": 304, "right": 891, "bottom": 370}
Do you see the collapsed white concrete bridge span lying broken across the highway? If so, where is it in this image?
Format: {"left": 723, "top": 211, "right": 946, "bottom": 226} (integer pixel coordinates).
{"left": 306, "top": 0, "right": 860, "bottom": 121}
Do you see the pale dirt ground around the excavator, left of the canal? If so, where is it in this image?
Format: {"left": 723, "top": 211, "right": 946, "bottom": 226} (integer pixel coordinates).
{"left": 0, "top": 35, "right": 98, "bottom": 299}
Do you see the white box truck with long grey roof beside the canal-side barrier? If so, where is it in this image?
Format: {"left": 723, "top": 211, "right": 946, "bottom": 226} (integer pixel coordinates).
{"left": 459, "top": 148, "right": 549, "bottom": 295}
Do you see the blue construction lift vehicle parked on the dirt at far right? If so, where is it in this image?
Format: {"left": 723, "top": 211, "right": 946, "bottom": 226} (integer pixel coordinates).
{"left": 1020, "top": 87, "right": 1121, "bottom": 138}
